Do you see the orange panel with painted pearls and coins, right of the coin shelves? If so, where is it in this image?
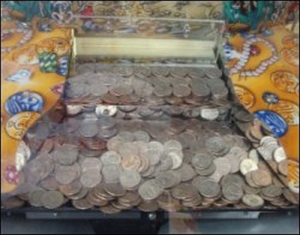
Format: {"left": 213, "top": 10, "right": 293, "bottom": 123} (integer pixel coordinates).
{"left": 224, "top": 26, "right": 299, "bottom": 194}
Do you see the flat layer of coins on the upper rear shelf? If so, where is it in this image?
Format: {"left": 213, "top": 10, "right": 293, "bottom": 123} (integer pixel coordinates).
{"left": 66, "top": 65, "right": 228, "bottom": 105}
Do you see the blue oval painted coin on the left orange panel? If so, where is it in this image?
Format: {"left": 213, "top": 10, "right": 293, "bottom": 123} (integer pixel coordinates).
{"left": 4, "top": 91, "right": 44, "bottom": 115}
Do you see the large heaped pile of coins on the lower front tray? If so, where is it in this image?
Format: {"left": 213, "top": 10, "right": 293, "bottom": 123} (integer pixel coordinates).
{"left": 2, "top": 115, "right": 299, "bottom": 214}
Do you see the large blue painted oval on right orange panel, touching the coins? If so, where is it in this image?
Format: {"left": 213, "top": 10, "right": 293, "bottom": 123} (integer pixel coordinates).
{"left": 254, "top": 110, "right": 288, "bottom": 138}
